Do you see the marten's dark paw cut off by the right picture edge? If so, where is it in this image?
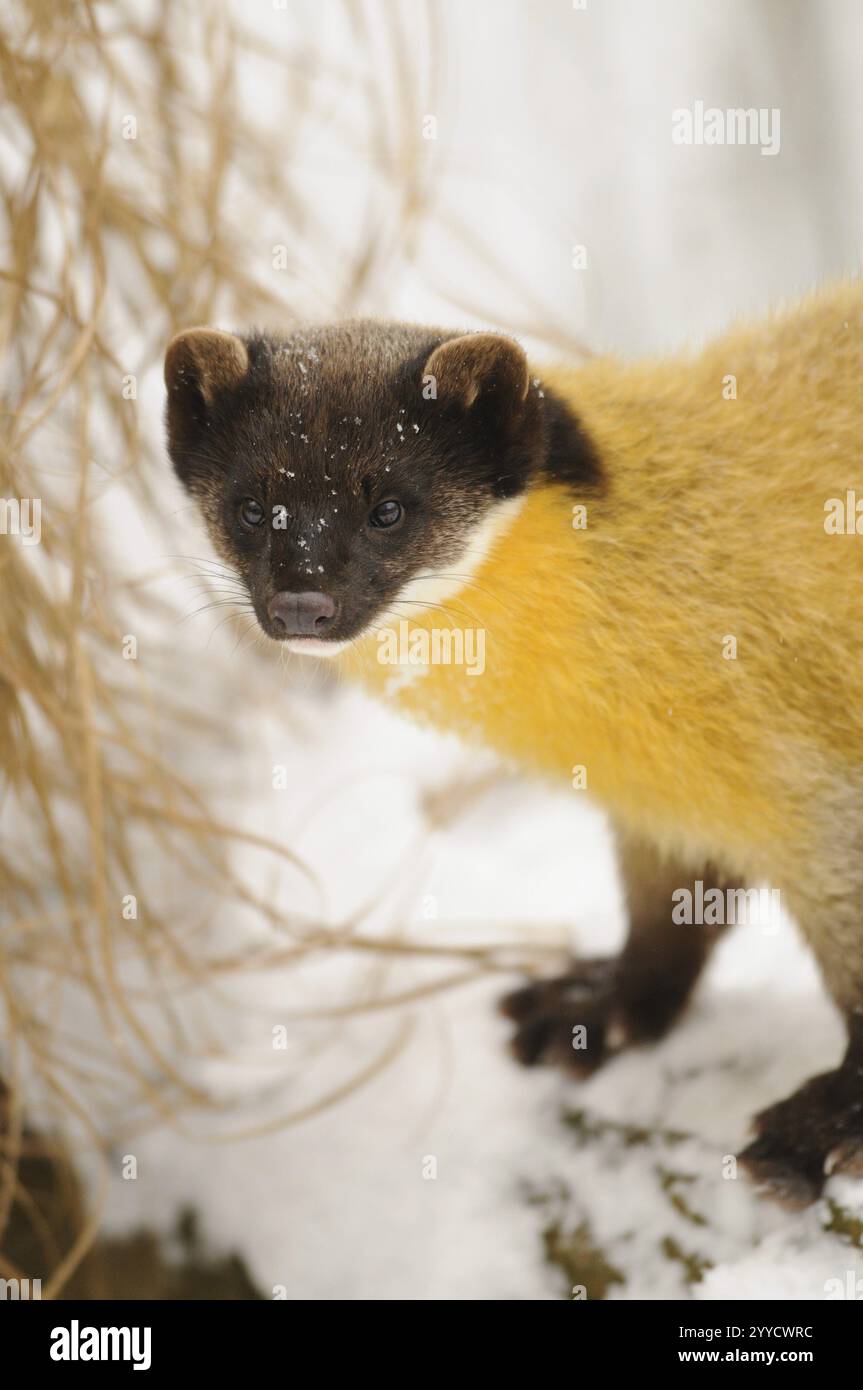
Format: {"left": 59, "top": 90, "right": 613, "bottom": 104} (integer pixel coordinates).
{"left": 739, "top": 1066, "right": 863, "bottom": 1209}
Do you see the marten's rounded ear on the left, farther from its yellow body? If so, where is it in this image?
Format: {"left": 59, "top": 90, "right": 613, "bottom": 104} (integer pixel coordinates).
{"left": 165, "top": 328, "right": 249, "bottom": 453}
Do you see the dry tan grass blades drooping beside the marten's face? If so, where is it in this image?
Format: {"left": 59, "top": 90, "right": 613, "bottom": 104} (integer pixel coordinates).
{"left": 0, "top": 0, "right": 569, "bottom": 1295}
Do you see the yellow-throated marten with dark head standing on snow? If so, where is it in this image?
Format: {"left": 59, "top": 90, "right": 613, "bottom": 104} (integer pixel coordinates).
{"left": 165, "top": 282, "right": 863, "bottom": 1205}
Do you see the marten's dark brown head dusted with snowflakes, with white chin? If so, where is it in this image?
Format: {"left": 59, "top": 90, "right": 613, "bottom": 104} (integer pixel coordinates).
{"left": 165, "top": 322, "right": 586, "bottom": 655}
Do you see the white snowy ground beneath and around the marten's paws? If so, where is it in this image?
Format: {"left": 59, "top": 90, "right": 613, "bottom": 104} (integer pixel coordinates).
{"left": 92, "top": 656, "right": 863, "bottom": 1300}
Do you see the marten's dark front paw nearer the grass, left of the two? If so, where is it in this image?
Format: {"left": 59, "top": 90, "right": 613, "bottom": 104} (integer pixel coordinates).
{"left": 500, "top": 956, "right": 632, "bottom": 1076}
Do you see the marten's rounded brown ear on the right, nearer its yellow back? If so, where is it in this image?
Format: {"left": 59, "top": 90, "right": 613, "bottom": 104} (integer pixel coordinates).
{"left": 422, "top": 334, "right": 531, "bottom": 425}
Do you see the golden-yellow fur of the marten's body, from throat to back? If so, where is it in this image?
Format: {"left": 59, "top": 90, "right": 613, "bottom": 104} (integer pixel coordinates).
{"left": 342, "top": 282, "right": 863, "bottom": 883}
